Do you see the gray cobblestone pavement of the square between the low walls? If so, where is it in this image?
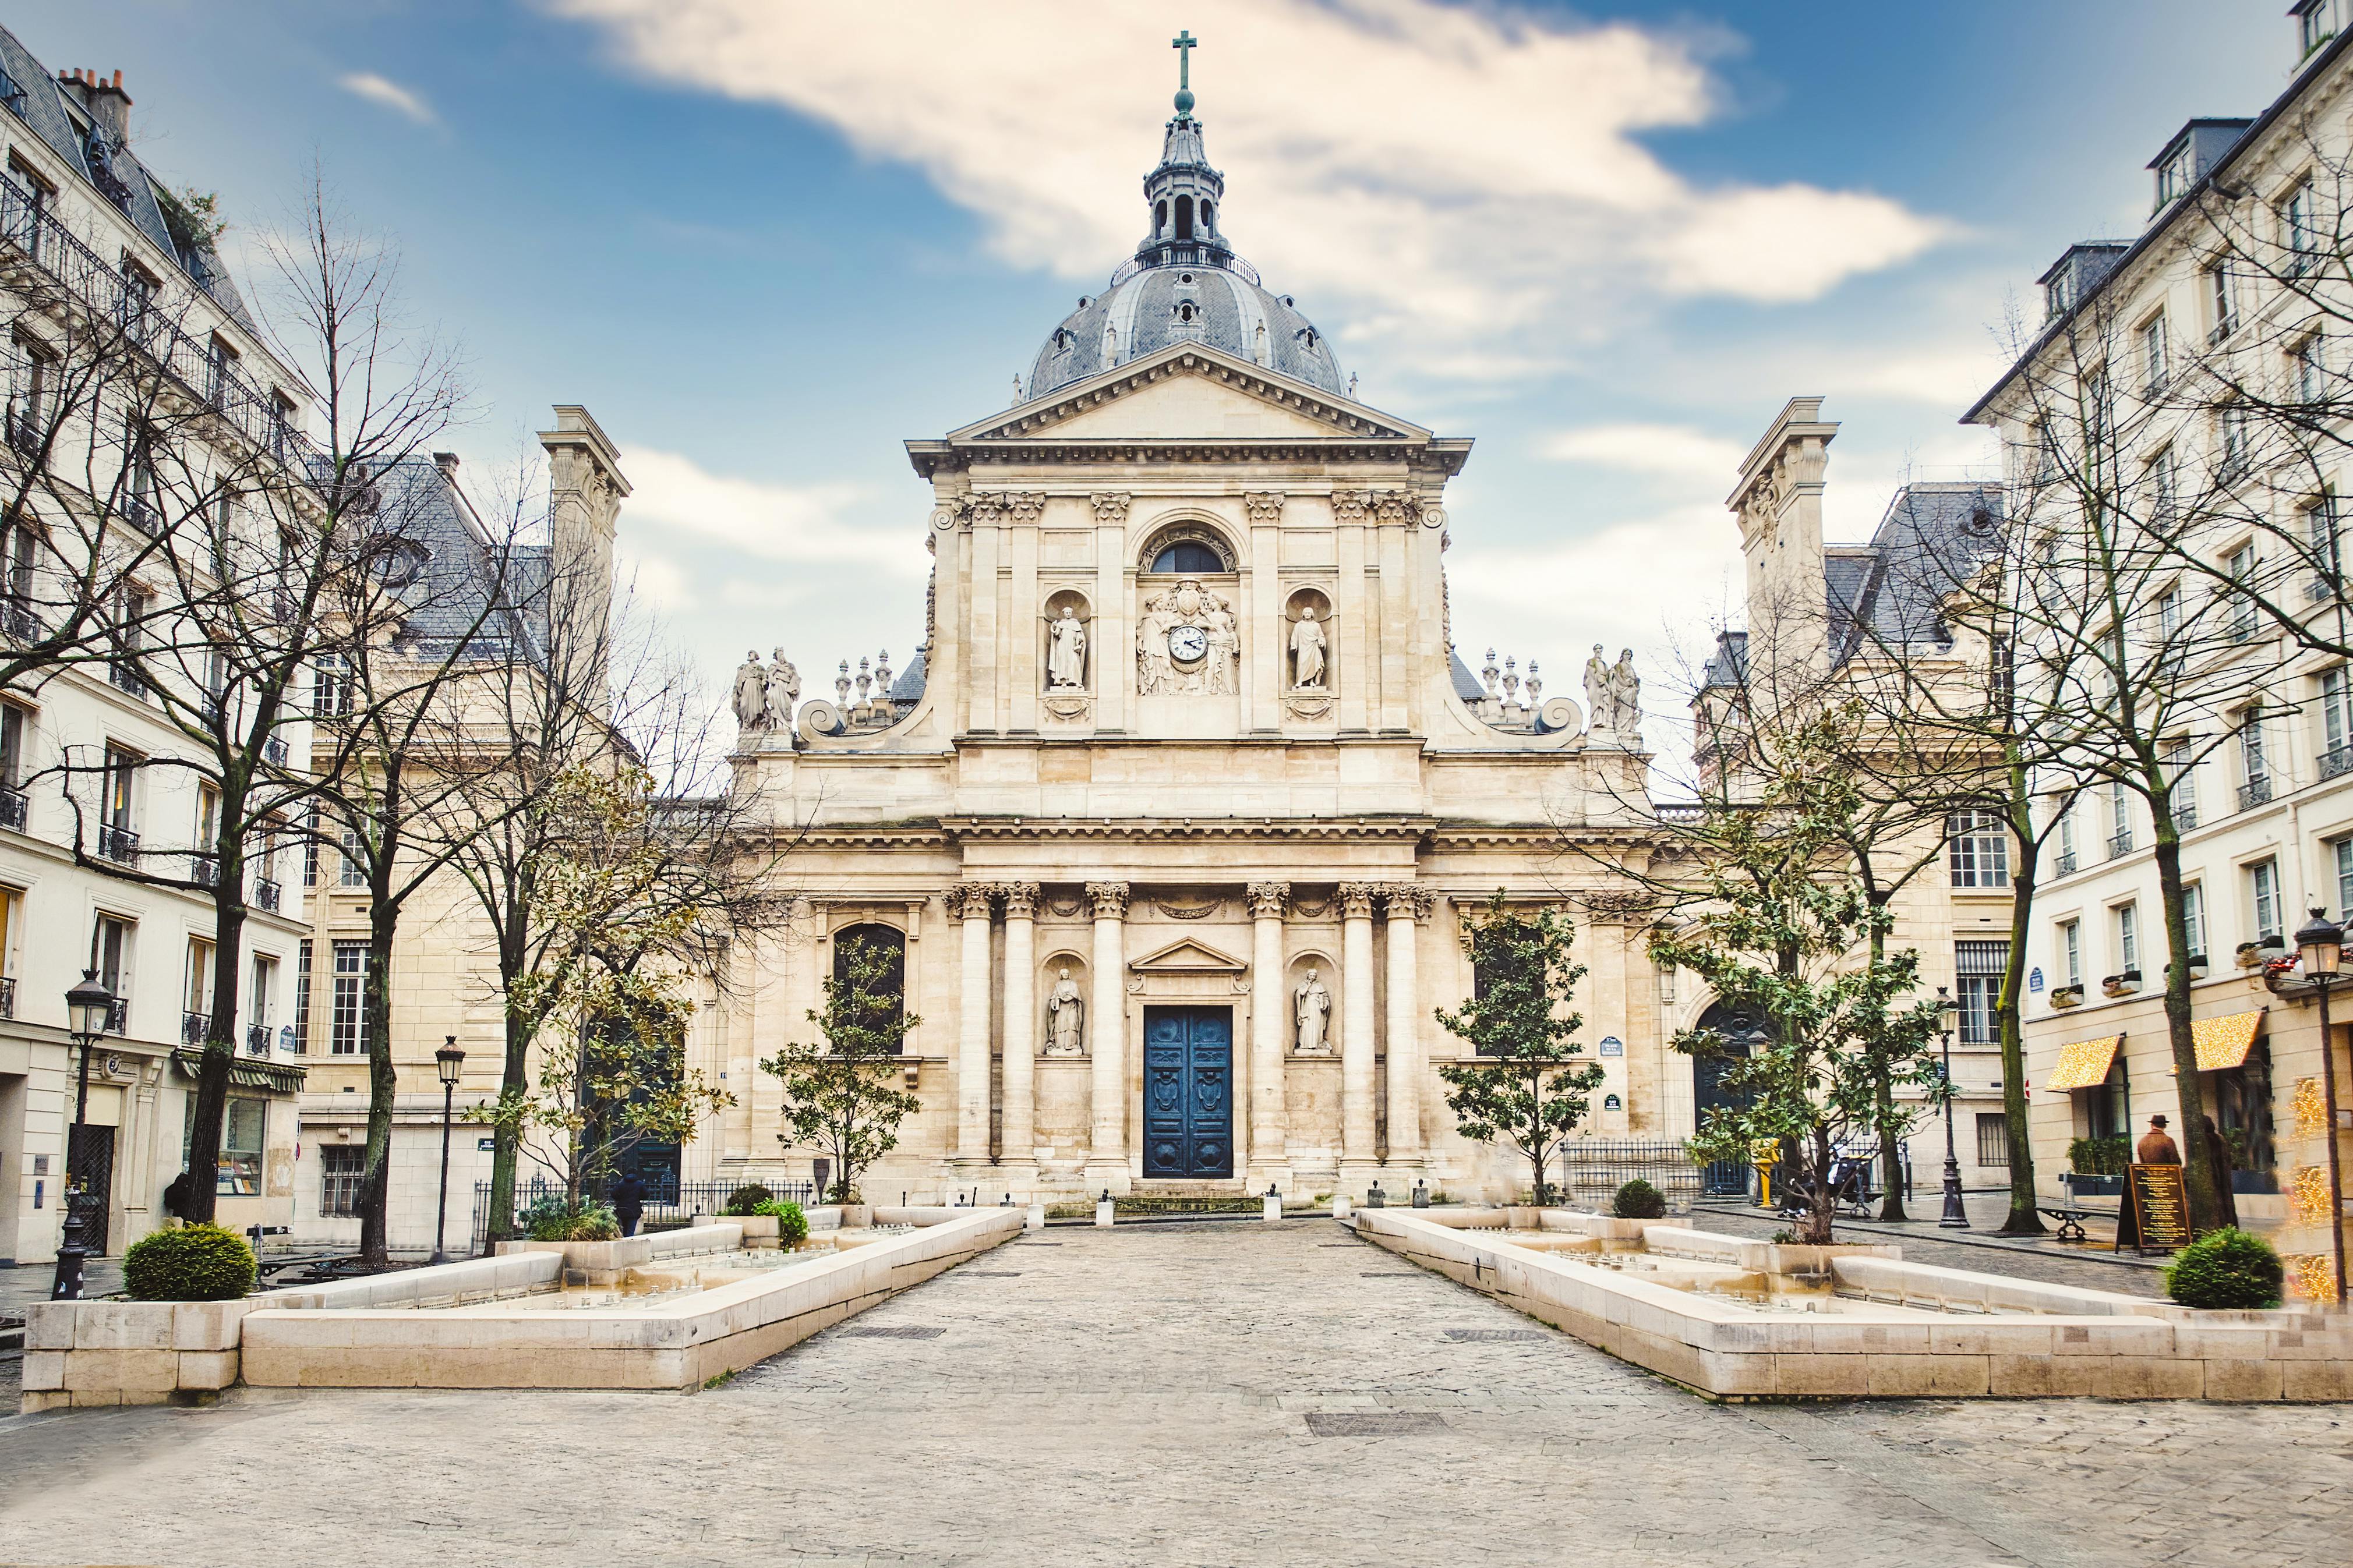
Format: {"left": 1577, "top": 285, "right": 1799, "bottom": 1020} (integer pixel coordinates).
{"left": 0, "top": 1220, "right": 2353, "bottom": 1568}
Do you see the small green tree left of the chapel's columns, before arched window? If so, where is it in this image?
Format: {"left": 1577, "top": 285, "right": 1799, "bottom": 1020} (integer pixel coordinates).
{"left": 760, "top": 938, "right": 923, "bottom": 1204}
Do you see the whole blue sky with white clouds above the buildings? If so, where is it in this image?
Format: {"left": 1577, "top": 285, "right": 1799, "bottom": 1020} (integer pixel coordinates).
{"left": 0, "top": 0, "right": 2297, "bottom": 742}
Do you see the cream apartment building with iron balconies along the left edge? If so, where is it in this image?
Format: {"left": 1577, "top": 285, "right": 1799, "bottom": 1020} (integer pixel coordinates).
{"left": 0, "top": 30, "right": 310, "bottom": 1262}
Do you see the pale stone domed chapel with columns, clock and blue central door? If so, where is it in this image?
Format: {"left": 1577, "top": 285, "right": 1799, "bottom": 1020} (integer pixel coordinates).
{"left": 706, "top": 106, "right": 1692, "bottom": 1204}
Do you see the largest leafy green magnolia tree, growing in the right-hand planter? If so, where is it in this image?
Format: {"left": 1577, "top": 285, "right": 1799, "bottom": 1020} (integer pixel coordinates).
{"left": 1649, "top": 724, "right": 1948, "bottom": 1244}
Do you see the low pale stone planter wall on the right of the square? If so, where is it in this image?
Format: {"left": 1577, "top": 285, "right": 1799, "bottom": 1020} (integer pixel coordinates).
{"left": 1355, "top": 1210, "right": 2353, "bottom": 1401}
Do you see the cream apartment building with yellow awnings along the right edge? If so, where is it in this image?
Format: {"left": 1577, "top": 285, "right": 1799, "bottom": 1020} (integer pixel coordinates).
{"left": 1967, "top": 0, "right": 2353, "bottom": 1293}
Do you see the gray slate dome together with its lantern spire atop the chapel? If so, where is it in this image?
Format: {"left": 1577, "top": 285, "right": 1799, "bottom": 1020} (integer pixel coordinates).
{"left": 1026, "top": 91, "right": 1348, "bottom": 397}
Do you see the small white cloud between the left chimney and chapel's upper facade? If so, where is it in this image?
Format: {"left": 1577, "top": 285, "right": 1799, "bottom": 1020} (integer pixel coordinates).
{"left": 621, "top": 447, "right": 930, "bottom": 581}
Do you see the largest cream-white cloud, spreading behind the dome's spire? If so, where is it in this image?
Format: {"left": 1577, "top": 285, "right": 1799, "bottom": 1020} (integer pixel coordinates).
{"left": 541, "top": 0, "right": 1948, "bottom": 378}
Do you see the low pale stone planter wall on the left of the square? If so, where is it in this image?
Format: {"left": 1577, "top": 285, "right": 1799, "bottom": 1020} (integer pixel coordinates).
{"left": 21, "top": 1208, "right": 1023, "bottom": 1413}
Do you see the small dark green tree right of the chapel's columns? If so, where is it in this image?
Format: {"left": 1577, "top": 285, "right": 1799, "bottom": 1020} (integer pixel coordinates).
{"left": 1437, "top": 889, "right": 1602, "bottom": 1204}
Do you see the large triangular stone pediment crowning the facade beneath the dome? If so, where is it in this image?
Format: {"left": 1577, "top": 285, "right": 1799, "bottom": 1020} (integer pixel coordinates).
{"left": 948, "top": 343, "right": 1430, "bottom": 442}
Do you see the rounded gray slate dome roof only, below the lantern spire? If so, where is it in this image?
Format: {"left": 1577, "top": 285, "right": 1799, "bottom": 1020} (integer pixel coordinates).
{"left": 1028, "top": 261, "right": 1348, "bottom": 397}
